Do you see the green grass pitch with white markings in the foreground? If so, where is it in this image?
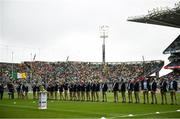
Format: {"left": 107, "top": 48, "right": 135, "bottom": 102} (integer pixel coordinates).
{"left": 0, "top": 93, "right": 180, "bottom": 119}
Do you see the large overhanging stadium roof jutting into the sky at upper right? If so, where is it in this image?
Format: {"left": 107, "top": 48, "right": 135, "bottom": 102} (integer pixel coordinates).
{"left": 128, "top": 2, "right": 180, "bottom": 28}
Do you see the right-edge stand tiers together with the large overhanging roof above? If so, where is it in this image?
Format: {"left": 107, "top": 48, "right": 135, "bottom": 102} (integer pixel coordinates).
{"left": 128, "top": 2, "right": 180, "bottom": 79}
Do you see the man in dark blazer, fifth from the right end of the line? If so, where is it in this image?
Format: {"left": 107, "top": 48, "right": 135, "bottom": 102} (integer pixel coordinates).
{"left": 134, "top": 79, "right": 140, "bottom": 103}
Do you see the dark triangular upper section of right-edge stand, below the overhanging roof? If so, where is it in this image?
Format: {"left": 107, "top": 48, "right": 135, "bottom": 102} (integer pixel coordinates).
{"left": 163, "top": 35, "right": 180, "bottom": 54}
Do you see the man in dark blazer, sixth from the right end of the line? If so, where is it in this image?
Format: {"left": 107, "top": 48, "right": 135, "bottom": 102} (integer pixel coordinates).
{"left": 127, "top": 80, "right": 134, "bottom": 103}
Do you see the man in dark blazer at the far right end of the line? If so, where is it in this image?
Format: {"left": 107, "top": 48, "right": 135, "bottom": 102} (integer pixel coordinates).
{"left": 169, "top": 77, "right": 177, "bottom": 105}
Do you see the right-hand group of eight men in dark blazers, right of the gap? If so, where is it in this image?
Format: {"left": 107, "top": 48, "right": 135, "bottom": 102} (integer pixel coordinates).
{"left": 113, "top": 77, "right": 178, "bottom": 104}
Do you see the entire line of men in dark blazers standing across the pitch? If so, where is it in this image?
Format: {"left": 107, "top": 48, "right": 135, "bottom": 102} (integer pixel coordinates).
{"left": 0, "top": 77, "right": 178, "bottom": 104}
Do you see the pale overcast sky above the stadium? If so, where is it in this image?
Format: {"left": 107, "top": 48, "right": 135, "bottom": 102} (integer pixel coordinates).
{"left": 0, "top": 0, "right": 179, "bottom": 76}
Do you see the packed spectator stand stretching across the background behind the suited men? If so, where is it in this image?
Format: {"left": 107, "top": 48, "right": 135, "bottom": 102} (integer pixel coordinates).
{"left": 0, "top": 60, "right": 164, "bottom": 82}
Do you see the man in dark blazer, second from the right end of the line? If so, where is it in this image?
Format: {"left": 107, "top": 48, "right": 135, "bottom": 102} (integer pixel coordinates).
{"left": 160, "top": 78, "right": 167, "bottom": 104}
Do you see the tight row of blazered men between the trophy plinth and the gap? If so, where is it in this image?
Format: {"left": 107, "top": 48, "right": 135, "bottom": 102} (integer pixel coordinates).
{"left": 43, "top": 80, "right": 108, "bottom": 102}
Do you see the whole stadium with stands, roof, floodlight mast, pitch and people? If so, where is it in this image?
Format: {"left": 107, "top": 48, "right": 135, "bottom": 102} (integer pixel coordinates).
{"left": 0, "top": 2, "right": 180, "bottom": 119}
